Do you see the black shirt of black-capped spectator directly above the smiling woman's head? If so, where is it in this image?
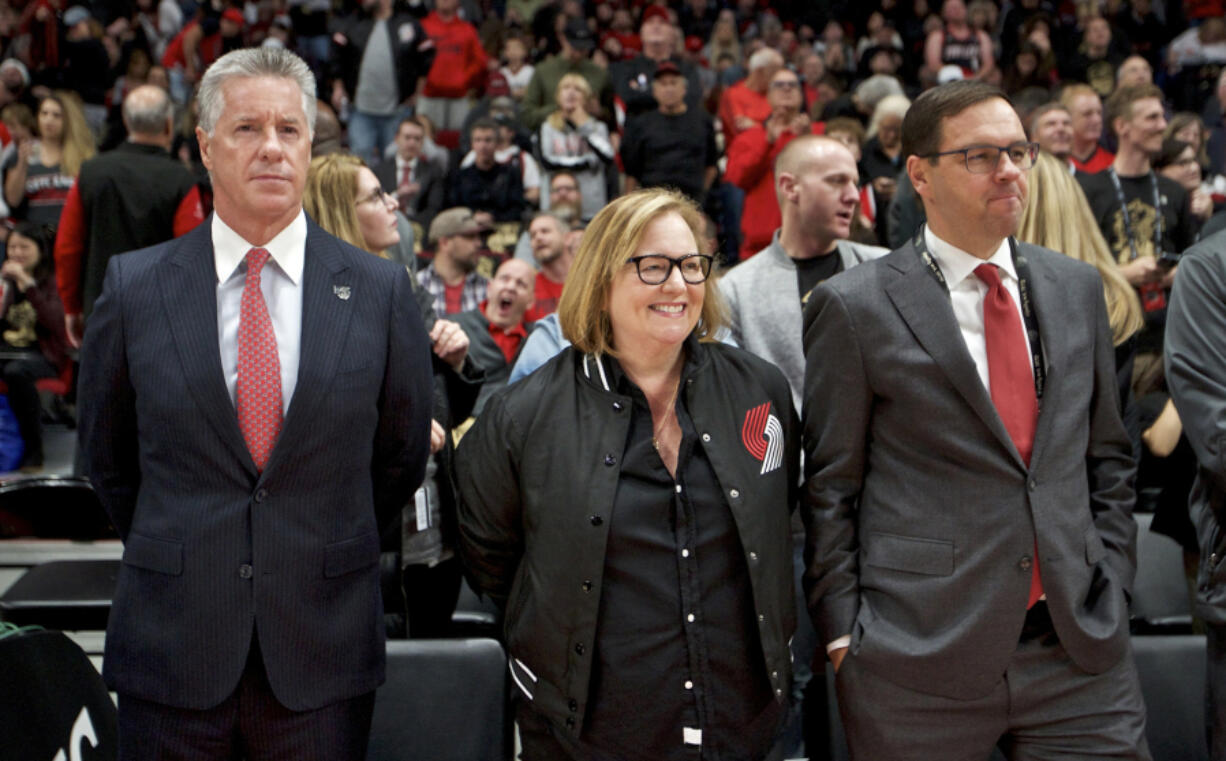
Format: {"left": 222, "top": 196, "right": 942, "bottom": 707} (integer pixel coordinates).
{"left": 622, "top": 109, "right": 720, "bottom": 202}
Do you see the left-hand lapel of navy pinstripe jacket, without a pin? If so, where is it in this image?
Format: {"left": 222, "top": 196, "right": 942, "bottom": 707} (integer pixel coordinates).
{"left": 162, "top": 218, "right": 256, "bottom": 474}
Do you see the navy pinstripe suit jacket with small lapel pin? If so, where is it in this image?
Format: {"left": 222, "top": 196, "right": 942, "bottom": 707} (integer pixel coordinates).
{"left": 80, "top": 215, "right": 432, "bottom": 711}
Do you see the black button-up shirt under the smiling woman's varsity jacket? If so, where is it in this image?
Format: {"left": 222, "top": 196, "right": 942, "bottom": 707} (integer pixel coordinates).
{"left": 577, "top": 355, "right": 781, "bottom": 761}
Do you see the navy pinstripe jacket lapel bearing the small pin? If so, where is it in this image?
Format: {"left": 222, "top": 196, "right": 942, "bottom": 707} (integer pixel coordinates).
{"left": 266, "top": 219, "right": 353, "bottom": 471}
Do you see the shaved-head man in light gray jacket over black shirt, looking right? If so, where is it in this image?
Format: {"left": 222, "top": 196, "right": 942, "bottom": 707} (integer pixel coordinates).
{"left": 720, "top": 135, "right": 885, "bottom": 409}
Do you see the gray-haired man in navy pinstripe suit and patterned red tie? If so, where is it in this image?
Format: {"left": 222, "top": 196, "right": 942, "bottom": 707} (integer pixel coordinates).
{"left": 80, "top": 48, "right": 432, "bottom": 761}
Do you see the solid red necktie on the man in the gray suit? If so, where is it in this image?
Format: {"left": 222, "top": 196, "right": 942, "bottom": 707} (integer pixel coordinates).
{"left": 975, "top": 265, "right": 1043, "bottom": 608}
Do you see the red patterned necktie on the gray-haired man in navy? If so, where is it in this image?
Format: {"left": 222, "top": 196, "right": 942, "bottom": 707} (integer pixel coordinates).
{"left": 235, "top": 249, "right": 281, "bottom": 472}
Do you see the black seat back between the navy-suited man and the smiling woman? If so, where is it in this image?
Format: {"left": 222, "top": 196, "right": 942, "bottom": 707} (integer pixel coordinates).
{"left": 367, "top": 638, "right": 512, "bottom": 761}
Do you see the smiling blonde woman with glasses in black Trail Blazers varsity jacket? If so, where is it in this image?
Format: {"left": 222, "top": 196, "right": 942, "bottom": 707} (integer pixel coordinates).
{"left": 456, "top": 189, "right": 799, "bottom": 761}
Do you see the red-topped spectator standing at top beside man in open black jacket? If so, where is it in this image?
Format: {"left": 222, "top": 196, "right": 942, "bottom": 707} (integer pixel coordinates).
{"left": 417, "top": 0, "right": 488, "bottom": 130}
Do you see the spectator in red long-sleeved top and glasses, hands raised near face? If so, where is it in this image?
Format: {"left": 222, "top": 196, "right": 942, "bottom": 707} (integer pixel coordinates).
{"left": 726, "top": 69, "right": 824, "bottom": 260}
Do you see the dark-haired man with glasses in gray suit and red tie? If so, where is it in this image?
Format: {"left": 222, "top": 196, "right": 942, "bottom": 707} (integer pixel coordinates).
{"left": 803, "top": 81, "right": 1149, "bottom": 761}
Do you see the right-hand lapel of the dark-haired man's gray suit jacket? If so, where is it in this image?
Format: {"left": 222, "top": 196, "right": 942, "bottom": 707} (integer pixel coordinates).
{"left": 1018, "top": 244, "right": 1069, "bottom": 468}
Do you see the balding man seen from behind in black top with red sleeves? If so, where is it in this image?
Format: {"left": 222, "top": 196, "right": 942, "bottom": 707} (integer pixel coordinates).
{"left": 55, "top": 85, "right": 205, "bottom": 347}
